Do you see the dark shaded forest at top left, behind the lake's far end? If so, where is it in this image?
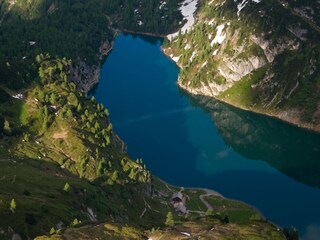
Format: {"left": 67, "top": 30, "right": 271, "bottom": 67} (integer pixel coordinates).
{"left": 0, "top": 0, "right": 182, "bottom": 91}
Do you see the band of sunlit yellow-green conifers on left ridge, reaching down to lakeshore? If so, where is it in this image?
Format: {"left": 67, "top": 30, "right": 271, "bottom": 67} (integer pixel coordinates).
{"left": 30, "top": 55, "right": 150, "bottom": 184}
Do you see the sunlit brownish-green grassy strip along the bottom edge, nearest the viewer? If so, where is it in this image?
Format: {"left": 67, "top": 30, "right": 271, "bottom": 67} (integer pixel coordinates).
{"left": 36, "top": 217, "right": 284, "bottom": 240}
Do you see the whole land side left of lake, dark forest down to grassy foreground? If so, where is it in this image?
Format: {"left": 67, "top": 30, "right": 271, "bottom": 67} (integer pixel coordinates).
{"left": 0, "top": 0, "right": 297, "bottom": 240}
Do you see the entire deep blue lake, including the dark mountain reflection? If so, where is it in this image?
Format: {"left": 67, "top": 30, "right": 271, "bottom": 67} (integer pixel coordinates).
{"left": 93, "top": 35, "right": 320, "bottom": 239}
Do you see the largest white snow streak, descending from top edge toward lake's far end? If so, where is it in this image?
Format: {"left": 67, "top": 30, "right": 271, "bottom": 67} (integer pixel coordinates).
{"left": 167, "top": 0, "right": 198, "bottom": 41}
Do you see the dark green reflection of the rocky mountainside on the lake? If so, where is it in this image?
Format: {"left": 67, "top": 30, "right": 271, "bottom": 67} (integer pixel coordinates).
{"left": 181, "top": 90, "right": 320, "bottom": 188}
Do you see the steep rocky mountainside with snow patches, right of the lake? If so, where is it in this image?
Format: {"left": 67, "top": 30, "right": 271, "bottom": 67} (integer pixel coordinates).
{"left": 164, "top": 0, "right": 320, "bottom": 131}
